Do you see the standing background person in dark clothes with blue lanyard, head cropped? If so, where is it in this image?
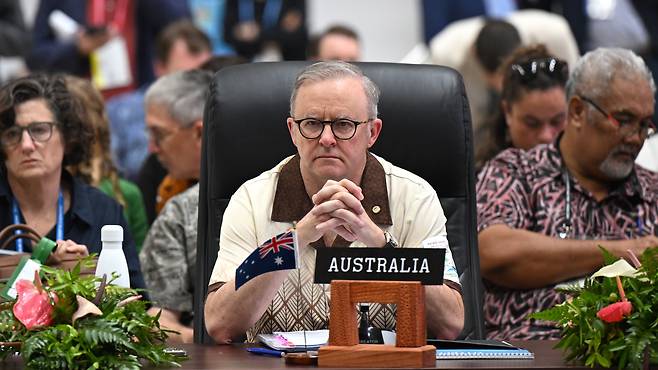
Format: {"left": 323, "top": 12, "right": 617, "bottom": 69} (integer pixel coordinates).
{"left": 224, "top": 0, "right": 308, "bottom": 61}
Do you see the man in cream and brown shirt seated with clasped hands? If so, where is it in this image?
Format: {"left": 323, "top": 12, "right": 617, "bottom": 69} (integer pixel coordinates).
{"left": 205, "top": 61, "right": 464, "bottom": 343}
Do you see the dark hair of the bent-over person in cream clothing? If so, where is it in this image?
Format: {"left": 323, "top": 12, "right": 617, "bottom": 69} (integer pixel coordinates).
{"left": 475, "top": 19, "right": 521, "bottom": 73}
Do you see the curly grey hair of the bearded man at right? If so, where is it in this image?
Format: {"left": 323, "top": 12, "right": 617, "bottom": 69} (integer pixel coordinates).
{"left": 566, "top": 48, "right": 656, "bottom": 101}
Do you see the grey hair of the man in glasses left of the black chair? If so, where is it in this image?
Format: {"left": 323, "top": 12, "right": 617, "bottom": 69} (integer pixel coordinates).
{"left": 144, "top": 69, "right": 213, "bottom": 127}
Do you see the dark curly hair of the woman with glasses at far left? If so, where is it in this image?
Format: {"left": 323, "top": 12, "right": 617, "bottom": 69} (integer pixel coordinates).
{"left": 0, "top": 74, "right": 94, "bottom": 166}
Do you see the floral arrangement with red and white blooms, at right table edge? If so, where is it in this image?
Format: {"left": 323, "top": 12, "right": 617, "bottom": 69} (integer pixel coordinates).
{"left": 530, "top": 248, "right": 658, "bottom": 369}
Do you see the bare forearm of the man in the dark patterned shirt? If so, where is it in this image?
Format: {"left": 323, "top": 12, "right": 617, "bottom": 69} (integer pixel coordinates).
{"left": 478, "top": 225, "right": 632, "bottom": 289}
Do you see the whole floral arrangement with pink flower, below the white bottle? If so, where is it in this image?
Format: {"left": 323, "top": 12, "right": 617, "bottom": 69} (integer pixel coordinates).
{"left": 0, "top": 257, "right": 181, "bottom": 369}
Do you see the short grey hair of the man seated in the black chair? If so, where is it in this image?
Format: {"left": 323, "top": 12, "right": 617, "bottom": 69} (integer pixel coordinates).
{"left": 290, "top": 60, "right": 379, "bottom": 119}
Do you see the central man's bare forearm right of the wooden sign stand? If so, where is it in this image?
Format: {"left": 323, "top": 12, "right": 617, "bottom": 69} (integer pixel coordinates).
{"left": 425, "top": 285, "right": 464, "bottom": 339}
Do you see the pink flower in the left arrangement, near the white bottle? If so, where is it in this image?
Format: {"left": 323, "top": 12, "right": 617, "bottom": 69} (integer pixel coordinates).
{"left": 13, "top": 279, "right": 57, "bottom": 330}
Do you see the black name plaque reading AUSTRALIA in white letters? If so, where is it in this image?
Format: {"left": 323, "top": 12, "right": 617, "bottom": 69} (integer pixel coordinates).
{"left": 315, "top": 248, "right": 446, "bottom": 285}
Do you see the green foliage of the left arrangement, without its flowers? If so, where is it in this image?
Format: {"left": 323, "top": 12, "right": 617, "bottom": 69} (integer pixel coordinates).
{"left": 0, "top": 258, "right": 180, "bottom": 369}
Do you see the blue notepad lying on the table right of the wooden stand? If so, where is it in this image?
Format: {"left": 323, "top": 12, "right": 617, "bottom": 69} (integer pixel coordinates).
{"left": 428, "top": 340, "right": 535, "bottom": 360}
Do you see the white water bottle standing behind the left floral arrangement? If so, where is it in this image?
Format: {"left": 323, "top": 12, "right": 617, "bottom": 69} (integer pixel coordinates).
{"left": 96, "top": 225, "right": 130, "bottom": 288}
